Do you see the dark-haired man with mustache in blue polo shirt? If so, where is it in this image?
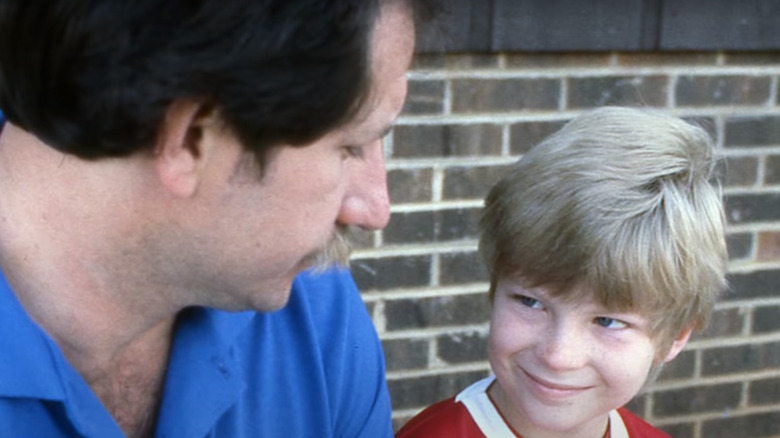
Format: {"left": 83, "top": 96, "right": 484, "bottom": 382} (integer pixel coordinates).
{"left": 0, "top": 0, "right": 430, "bottom": 437}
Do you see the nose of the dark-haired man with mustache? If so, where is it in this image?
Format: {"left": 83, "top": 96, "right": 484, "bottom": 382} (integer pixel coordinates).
{"left": 338, "top": 140, "right": 390, "bottom": 230}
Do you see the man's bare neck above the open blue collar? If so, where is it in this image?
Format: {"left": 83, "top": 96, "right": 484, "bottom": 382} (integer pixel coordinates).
{"left": 0, "top": 124, "right": 179, "bottom": 436}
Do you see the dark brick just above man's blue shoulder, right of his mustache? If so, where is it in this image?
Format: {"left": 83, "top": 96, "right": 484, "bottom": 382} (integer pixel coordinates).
{"left": 350, "top": 255, "right": 431, "bottom": 292}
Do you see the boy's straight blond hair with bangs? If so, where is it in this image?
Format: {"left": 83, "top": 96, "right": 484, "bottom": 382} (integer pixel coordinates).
{"left": 479, "top": 107, "right": 727, "bottom": 357}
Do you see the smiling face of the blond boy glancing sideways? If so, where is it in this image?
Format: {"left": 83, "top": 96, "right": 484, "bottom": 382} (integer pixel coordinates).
{"left": 488, "top": 279, "right": 687, "bottom": 437}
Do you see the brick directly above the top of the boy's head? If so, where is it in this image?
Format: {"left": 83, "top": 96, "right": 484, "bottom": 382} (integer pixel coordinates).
{"left": 567, "top": 76, "right": 669, "bottom": 108}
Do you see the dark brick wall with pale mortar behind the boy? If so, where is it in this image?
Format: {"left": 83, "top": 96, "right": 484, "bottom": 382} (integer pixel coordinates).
{"left": 352, "top": 52, "right": 780, "bottom": 438}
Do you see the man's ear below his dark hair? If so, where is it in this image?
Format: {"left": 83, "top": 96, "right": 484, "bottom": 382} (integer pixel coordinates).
{"left": 154, "top": 99, "right": 218, "bottom": 197}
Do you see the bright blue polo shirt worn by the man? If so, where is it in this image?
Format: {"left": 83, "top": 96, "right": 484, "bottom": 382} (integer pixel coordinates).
{"left": 0, "top": 270, "right": 392, "bottom": 438}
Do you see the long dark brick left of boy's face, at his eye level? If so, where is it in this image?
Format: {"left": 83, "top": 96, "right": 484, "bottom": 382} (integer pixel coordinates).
{"left": 385, "top": 293, "right": 490, "bottom": 330}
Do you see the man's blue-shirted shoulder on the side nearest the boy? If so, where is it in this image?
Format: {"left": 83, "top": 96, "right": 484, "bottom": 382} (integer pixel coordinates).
{"left": 164, "top": 270, "right": 392, "bottom": 437}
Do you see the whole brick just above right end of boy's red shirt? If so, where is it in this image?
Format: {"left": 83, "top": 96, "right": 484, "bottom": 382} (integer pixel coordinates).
{"left": 653, "top": 383, "right": 742, "bottom": 417}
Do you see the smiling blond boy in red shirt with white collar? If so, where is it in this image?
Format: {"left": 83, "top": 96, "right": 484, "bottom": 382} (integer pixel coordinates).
{"left": 397, "top": 107, "right": 727, "bottom": 438}
